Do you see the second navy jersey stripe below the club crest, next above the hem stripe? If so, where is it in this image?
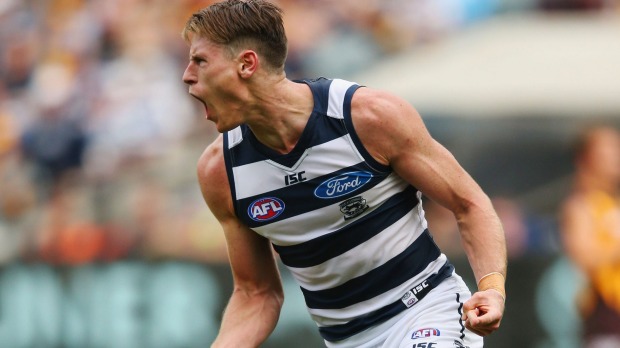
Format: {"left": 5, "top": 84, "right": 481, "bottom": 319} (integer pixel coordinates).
{"left": 301, "top": 230, "right": 441, "bottom": 309}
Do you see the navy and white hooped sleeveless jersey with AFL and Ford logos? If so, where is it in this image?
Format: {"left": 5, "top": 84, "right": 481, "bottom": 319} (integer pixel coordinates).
{"left": 224, "top": 78, "right": 453, "bottom": 342}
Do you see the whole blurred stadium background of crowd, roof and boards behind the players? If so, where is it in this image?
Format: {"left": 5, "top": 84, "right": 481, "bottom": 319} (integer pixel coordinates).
{"left": 0, "top": 0, "right": 620, "bottom": 348}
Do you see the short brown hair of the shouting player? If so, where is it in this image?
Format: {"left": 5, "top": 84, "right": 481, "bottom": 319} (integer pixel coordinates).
{"left": 182, "top": 0, "right": 287, "bottom": 71}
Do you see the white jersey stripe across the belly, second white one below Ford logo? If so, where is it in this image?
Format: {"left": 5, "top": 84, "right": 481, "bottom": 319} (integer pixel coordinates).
{"left": 289, "top": 211, "right": 424, "bottom": 291}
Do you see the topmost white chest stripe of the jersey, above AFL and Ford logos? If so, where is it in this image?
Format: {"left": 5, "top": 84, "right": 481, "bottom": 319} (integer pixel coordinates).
{"left": 233, "top": 136, "right": 363, "bottom": 199}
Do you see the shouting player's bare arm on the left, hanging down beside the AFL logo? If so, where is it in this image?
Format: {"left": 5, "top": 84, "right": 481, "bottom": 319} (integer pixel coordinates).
{"left": 198, "top": 136, "right": 284, "bottom": 348}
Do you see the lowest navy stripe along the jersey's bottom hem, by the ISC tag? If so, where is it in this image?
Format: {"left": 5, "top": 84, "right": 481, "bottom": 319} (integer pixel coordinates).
{"left": 319, "top": 261, "right": 458, "bottom": 342}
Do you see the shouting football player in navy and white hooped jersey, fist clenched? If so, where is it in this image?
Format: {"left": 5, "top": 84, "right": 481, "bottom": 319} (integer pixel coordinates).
{"left": 183, "top": 0, "right": 506, "bottom": 348}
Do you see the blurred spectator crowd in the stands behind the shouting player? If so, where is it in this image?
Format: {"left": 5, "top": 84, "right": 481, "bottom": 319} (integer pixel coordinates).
{"left": 0, "top": 0, "right": 615, "bottom": 264}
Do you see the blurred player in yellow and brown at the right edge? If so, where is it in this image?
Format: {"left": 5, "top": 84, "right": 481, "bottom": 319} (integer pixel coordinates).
{"left": 561, "top": 126, "right": 620, "bottom": 348}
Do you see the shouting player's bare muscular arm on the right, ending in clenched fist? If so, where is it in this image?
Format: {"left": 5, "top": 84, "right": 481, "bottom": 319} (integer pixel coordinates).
{"left": 352, "top": 88, "right": 506, "bottom": 335}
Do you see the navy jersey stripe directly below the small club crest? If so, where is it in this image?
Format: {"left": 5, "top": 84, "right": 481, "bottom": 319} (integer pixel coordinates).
{"left": 274, "top": 186, "right": 418, "bottom": 268}
